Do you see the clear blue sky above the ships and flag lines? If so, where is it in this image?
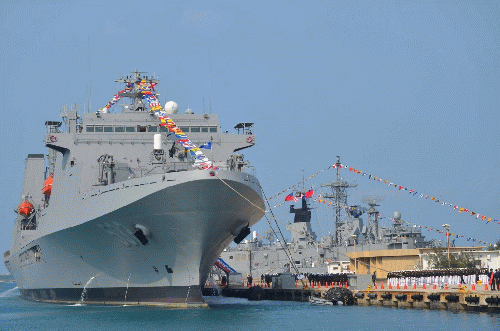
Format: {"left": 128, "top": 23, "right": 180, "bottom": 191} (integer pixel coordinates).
{"left": 0, "top": 0, "right": 500, "bottom": 273}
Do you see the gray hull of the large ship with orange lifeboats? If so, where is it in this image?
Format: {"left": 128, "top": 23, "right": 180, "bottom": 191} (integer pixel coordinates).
{"left": 5, "top": 170, "right": 264, "bottom": 307}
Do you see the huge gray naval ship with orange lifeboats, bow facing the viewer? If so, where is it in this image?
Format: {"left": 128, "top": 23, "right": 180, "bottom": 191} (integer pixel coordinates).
{"left": 4, "top": 69, "right": 265, "bottom": 307}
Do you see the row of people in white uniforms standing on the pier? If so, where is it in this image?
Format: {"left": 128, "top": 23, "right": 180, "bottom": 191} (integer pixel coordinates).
{"left": 387, "top": 268, "right": 500, "bottom": 287}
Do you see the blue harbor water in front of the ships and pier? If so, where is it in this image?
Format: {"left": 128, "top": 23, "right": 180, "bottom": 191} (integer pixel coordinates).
{"left": 0, "top": 283, "right": 500, "bottom": 331}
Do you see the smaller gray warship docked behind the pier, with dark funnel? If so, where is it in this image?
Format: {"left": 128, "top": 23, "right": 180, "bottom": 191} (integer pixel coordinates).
{"left": 221, "top": 157, "right": 432, "bottom": 279}
